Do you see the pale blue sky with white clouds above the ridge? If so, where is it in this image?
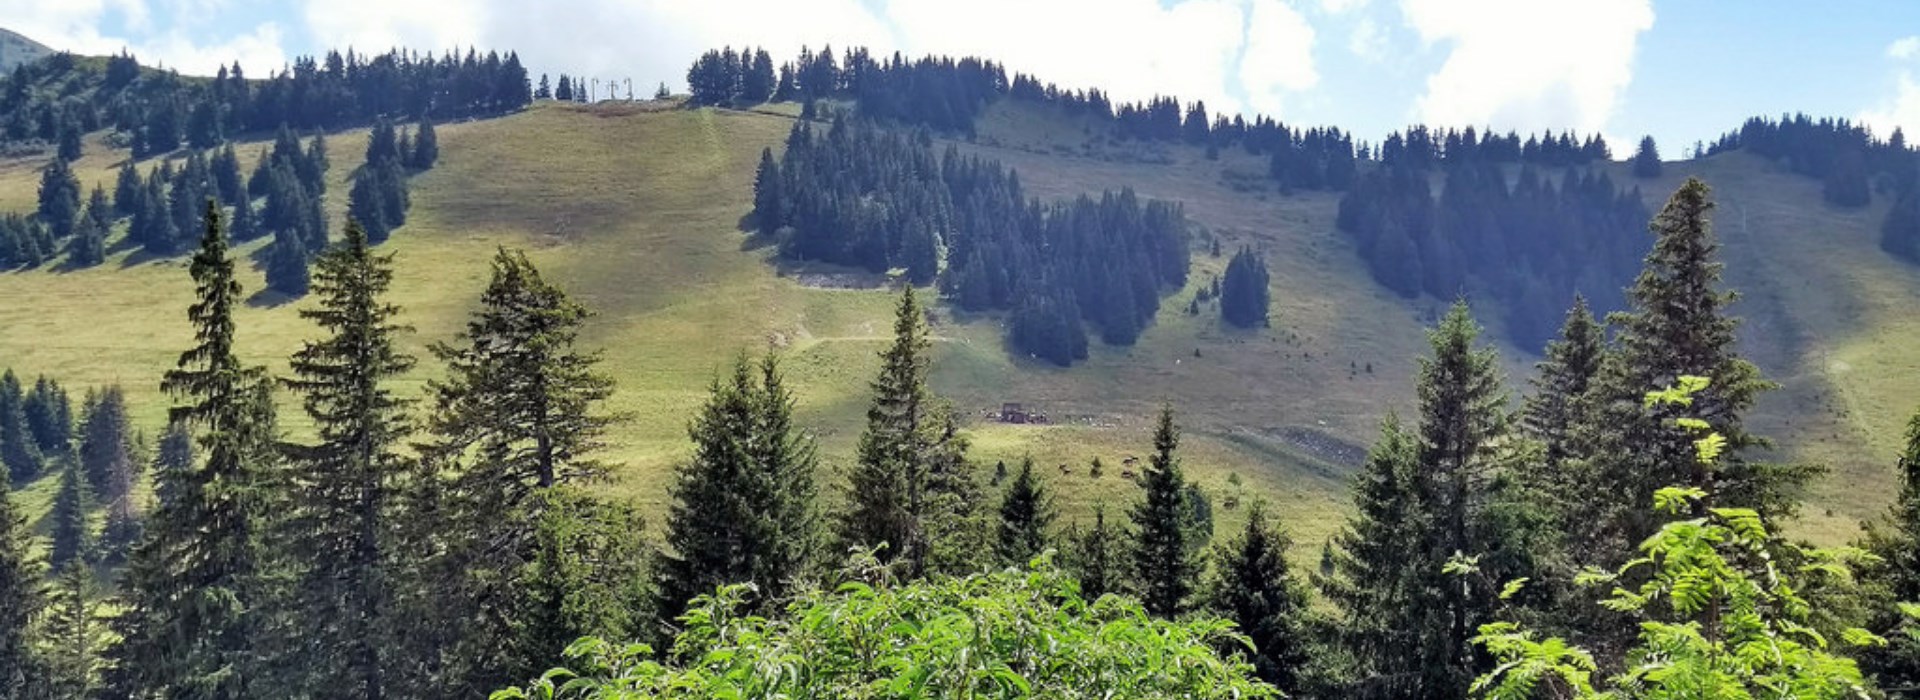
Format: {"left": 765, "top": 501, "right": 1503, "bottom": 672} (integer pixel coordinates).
{"left": 0, "top": 0, "right": 1920, "bottom": 157}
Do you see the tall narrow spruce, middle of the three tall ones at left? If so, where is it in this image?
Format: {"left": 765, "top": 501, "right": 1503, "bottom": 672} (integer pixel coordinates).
{"left": 282, "top": 221, "right": 413, "bottom": 698}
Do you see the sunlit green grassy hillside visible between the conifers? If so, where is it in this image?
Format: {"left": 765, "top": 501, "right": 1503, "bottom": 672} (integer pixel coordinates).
{"left": 0, "top": 95, "right": 1920, "bottom": 554}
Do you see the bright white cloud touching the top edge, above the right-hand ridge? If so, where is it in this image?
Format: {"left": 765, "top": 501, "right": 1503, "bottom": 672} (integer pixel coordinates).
{"left": 1402, "top": 0, "right": 1653, "bottom": 132}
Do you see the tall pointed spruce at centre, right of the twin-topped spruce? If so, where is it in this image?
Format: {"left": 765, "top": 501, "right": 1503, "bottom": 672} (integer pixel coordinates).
{"left": 839, "top": 286, "right": 970, "bottom": 577}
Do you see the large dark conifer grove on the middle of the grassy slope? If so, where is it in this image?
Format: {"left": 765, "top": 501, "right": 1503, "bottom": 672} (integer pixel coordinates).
{"left": 753, "top": 119, "right": 1190, "bottom": 366}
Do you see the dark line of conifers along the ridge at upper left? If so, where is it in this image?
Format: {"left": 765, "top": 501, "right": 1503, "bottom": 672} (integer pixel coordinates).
{"left": 0, "top": 50, "right": 532, "bottom": 159}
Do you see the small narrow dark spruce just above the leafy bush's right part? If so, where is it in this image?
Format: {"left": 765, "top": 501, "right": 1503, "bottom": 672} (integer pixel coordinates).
{"left": 1131, "top": 407, "right": 1204, "bottom": 618}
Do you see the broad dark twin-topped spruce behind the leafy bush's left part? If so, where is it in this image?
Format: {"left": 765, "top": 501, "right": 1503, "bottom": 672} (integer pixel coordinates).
{"left": 655, "top": 355, "right": 818, "bottom": 619}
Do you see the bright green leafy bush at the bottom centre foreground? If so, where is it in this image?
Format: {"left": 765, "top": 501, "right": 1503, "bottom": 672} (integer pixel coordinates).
{"left": 493, "top": 556, "right": 1279, "bottom": 700}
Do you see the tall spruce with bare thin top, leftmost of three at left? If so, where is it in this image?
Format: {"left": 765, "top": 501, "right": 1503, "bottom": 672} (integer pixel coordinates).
{"left": 113, "top": 203, "right": 275, "bottom": 698}
